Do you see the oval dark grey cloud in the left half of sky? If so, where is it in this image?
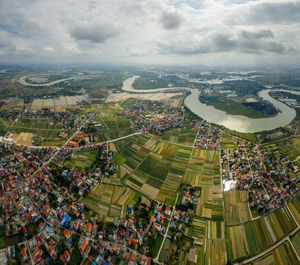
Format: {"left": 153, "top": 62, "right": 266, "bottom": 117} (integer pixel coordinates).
{"left": 70, "top": 24, "right": 120, "bottom": 43}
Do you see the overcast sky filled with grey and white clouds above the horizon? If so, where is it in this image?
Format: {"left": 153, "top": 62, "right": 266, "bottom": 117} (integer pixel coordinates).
{"left": 0, "top": 0, "right": 300, "bottom": 66}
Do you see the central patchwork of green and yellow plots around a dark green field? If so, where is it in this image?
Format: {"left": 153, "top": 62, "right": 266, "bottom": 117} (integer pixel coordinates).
{"left": 117, "top": 136, "right": 192, "bottom": 205}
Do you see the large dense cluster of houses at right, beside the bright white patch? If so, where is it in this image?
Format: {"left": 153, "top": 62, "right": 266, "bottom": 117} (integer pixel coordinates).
{"left": 221, "top": 143, "right": 300, "bottom": 214}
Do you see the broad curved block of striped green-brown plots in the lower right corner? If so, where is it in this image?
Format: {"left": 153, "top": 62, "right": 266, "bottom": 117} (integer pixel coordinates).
{"left": 226, "top": 207, "right": 296, "bottom": 261}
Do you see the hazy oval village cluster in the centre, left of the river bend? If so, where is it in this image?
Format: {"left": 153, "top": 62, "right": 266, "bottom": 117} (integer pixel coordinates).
{"left": 118, "top": 100, "right": 184, "bottom": 135}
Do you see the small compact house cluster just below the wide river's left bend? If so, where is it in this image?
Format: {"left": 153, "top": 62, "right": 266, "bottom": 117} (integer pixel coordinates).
{"left": 194, "top": 121, "right": 222, "bottom": 150}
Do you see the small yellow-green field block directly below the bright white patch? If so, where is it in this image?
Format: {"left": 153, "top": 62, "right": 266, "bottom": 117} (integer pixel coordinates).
{"left": 224, "top": 190, "right": 251, "bottom": 226}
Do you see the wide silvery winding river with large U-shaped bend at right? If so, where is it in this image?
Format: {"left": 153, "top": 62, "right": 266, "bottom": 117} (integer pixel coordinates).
{"left": 122, "top": 76, "right": 300, "bottom": 133}
